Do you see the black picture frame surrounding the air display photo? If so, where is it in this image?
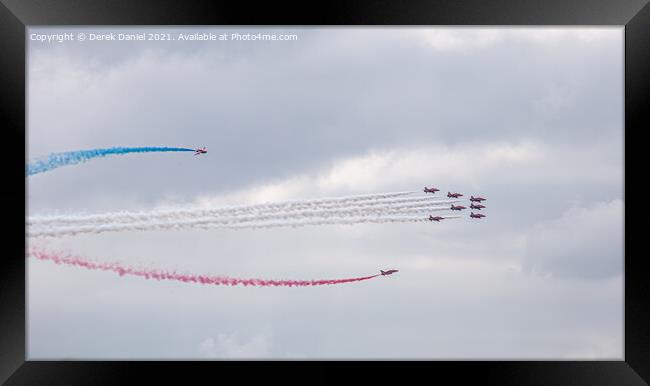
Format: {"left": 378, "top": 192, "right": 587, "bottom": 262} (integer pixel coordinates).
{"left": 0, "top": 0, "right": 650, "bottom": 385}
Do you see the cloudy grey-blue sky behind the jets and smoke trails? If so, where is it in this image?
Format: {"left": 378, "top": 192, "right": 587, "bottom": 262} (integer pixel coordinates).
{"left": 27, "top": 27, "right": 624, "bottom": 359}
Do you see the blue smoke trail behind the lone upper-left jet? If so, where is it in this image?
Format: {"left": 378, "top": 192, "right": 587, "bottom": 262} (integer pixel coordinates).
{"left": 26, "top": 147, "right": 194, "bottom": 176}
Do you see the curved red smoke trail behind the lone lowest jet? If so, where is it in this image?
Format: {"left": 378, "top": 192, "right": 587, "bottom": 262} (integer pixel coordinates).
{"left": 29, "top": 249, "right": 379, "bottom": 287}
